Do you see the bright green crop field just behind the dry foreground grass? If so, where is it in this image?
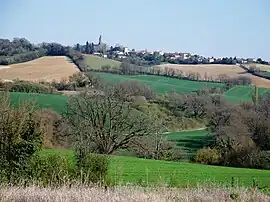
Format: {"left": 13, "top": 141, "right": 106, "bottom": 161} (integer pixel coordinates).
{"left": 42, "top": 150, "right": 270, "bottom": 187}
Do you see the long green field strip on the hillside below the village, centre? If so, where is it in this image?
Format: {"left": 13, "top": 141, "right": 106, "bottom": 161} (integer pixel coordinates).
{"left": 96, "top": 73, "right": 224, "bottom": 93}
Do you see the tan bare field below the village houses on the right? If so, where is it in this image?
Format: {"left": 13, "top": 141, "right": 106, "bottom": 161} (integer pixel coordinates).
{"left": 157, "top": 64, "right": 270, "bottom": 88}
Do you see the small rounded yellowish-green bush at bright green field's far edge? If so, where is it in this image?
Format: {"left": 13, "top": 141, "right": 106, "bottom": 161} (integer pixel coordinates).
{"left": 195, "top": 147, "right": 221, "bottom": 165}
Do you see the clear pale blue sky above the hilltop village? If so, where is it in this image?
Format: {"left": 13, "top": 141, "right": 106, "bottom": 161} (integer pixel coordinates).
{"left": 0, "top": 0, "right": 270, "bottom": 60}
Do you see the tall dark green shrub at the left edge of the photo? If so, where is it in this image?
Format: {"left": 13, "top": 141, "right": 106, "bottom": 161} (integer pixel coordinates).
{"left": 0, "top": 93, "right": 42, "bottom": 183}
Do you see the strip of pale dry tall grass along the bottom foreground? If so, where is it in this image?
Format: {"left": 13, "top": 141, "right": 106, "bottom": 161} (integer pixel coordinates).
{"left": 0, "top": 186, "right": 270, "bottom": 202}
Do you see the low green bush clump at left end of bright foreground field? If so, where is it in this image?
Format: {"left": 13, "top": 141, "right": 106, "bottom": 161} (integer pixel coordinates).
{"left": 11, "top": 152, "right": 109, "bottom": 186}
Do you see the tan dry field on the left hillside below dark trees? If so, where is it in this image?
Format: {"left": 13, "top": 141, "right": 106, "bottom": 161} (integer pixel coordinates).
{"left": 0, "top": 56, "right": 79, "bottom": 81}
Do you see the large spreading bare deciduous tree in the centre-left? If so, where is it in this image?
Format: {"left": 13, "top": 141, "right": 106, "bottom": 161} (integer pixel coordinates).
{"left": 66, "top": 86, "right": 157, "bottom": 154}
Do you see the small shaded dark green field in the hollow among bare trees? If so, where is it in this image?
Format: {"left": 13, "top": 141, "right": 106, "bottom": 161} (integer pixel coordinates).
{"left": 166, "top": 129, "right": 211, "bottom": 159}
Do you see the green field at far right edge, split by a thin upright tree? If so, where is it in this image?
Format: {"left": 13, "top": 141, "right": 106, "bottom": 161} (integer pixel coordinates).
{"left": 224, "top": 86, "right": 270, "bottom": 103}
